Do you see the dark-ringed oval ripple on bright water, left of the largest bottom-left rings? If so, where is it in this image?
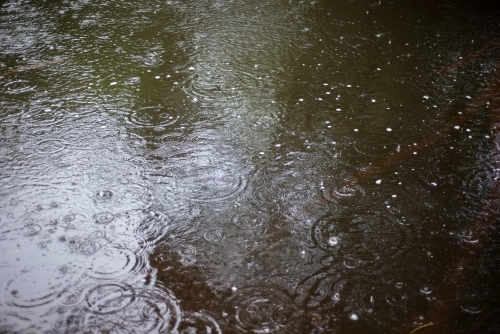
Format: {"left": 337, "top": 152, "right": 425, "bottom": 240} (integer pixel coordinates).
{"left": 83, "top": 284, "right": 135, "bottom": 315}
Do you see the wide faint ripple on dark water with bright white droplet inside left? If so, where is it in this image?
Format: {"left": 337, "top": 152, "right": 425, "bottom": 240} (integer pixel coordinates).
{"left": 311, "top": 214, "right": 404, "bottom": 261}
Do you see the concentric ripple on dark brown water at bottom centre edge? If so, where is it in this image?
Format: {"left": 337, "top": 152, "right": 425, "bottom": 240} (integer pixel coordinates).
{"left": 224, "top": 286, "right": 299, "bottom": 333}
